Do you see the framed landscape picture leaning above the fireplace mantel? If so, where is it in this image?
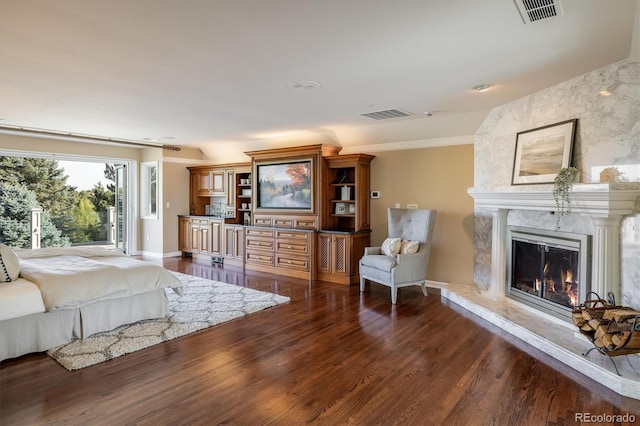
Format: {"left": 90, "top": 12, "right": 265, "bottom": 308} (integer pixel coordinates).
{"left": 511, "top": 118, "right": 578, "bottom": 185}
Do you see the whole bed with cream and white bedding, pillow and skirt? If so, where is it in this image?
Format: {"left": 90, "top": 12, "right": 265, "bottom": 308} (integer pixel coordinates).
{"left": 0, "top": 245, "right": 182, "bottom": 361}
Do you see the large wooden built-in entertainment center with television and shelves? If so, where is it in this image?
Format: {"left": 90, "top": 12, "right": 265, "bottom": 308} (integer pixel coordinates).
{"left": 179, "top": 144, "right": 375, "bottom": 285}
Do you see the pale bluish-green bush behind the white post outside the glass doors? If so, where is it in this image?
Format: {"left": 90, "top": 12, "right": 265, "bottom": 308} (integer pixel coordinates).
{"left": 0, "top": 183, "right": 70, "bottom": 248}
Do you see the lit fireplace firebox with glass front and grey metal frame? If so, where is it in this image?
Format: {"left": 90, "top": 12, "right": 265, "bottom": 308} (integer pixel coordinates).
{"left": 506, "top": 227, "right": 591, "bottom": 321}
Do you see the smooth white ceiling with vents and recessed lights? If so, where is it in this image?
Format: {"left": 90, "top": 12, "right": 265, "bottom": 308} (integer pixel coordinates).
{"left": 0, "top": 0, "right": 640, "bottom": 162}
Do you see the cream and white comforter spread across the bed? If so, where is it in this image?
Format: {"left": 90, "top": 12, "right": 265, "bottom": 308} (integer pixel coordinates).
{"left": 16, "top": 247, "right": 182, "bottom": 311}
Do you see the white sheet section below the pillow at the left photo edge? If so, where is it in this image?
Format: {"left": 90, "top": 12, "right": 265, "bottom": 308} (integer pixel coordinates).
{"left": 0, "top": 278, "right": 45, "bottom": 321}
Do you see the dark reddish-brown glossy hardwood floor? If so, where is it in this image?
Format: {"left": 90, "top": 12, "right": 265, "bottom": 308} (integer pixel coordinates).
{"left": 0, "top": 258, "right": 640, "bottom": 425}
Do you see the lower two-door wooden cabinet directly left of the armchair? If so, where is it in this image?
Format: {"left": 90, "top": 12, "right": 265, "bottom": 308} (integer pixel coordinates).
{"left": 316, "top": 232, "right": 370, "bottom": 285}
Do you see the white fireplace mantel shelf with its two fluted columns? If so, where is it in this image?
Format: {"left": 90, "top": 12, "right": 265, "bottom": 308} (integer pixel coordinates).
{"left": 467, "top": 182, "right": 640, "bottom": 306}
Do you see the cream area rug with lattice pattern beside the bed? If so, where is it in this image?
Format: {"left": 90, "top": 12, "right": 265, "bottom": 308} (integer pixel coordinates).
{"left": 47, "top": 272, "right": 289, "bottom": 370}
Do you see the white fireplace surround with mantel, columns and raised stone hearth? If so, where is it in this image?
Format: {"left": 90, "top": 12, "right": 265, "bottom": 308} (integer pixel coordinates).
{"left": 442, "top": 183, "right": 640, "bottom": 399}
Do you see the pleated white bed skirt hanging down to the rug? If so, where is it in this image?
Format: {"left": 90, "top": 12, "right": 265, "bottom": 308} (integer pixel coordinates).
{"left": 0, "top": 289, "right": 168, "bottom": 361}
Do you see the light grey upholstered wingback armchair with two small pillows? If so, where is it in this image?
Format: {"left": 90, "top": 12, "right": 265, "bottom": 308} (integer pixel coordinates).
{"left": 360, "top": 209, "right": 436, "bottom": 305}
